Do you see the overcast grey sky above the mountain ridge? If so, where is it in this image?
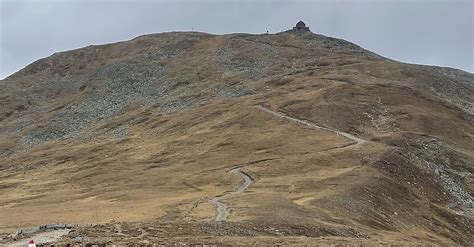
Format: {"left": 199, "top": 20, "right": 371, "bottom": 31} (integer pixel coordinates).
{"left": 0, "top": 0, "right": 474, "bottom": 78}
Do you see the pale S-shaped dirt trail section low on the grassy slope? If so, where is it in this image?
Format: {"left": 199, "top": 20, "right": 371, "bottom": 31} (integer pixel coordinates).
{"left": 209, "top": 167, "right": 252, "bottom": 221}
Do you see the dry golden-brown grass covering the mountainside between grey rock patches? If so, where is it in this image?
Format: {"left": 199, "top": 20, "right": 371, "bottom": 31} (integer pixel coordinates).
{"left": 0, "top": 30, "right": 474, "bottom": 244}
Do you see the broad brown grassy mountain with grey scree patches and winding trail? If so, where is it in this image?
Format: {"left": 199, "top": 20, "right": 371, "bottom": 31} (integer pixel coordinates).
{"left": 0, "top": 25, "right": 474, "bottom": 245}
